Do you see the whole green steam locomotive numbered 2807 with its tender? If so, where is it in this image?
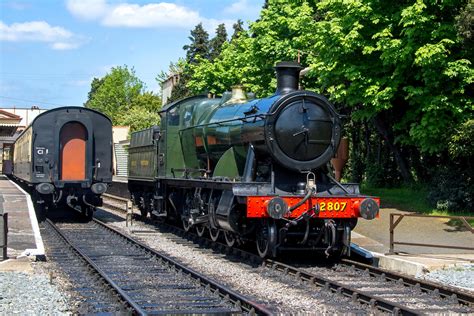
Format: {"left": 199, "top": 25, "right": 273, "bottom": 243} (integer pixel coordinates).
{"left": 128, "top": 62, "right": 379, "bottom": 257}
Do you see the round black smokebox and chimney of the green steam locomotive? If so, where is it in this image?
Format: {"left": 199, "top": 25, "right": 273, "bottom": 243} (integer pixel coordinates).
{"left": 265, "top": 63, "right": 341, "bottom": 171}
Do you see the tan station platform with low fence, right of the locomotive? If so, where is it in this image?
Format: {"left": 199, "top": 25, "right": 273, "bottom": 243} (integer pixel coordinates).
{"left": 352, "top": 208, "right": 474, "bottom": 276}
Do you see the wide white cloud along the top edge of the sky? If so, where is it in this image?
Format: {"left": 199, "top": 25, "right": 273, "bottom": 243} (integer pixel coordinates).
{"left": 67, "top": 0, "right": 233, "bottom": 32}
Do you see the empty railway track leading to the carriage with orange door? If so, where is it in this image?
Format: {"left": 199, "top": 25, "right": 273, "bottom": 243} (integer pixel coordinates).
{"left": 43, "top": 214, "right": 272, "bottom": 315}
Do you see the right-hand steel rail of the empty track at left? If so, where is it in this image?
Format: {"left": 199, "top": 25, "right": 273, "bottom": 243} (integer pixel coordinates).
{"left": 93, "top": 218, "right": 274, "bottom": 315}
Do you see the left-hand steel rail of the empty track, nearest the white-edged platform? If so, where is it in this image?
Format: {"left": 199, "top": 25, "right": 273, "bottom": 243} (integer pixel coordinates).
{"left": 46, "top": 219, "right": 147, "bottom": 315}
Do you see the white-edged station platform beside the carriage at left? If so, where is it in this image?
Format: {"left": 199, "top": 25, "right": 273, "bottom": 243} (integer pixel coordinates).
{"left": 0, "top": 175, "right": 45, "bottom": 259}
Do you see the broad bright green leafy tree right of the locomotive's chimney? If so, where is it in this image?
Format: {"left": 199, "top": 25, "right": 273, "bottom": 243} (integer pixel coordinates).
{"left": 308, "top": 0, "right": 474, "bottom": 180}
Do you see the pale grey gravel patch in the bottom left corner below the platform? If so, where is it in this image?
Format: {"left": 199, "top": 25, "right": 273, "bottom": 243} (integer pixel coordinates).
{"left": 0, "top": 271, "right": 72, "bottom": 315}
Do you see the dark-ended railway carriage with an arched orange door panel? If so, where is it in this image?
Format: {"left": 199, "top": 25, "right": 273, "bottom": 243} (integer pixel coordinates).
{"left": 13, "top": 107, "right": 112, "bottom": 218}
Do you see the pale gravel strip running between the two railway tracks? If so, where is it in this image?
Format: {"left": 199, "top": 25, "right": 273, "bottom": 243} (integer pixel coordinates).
{"left": 96, "top": 209, "right": 367, "bottom": 314}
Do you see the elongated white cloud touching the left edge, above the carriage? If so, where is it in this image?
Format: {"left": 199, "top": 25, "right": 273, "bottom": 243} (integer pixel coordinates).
{"left": 0, "top": 21, "right": 84, "bottom": 50}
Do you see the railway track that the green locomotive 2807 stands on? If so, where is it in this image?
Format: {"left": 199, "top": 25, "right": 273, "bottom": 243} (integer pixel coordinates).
{"left": 102, "top": 194, "right": 474, "bottom": 315}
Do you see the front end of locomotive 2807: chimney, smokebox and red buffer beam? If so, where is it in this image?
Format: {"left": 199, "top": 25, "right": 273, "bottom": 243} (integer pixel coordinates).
{"left": 243, "top": 62, "right": 379, "bottom": 256}
